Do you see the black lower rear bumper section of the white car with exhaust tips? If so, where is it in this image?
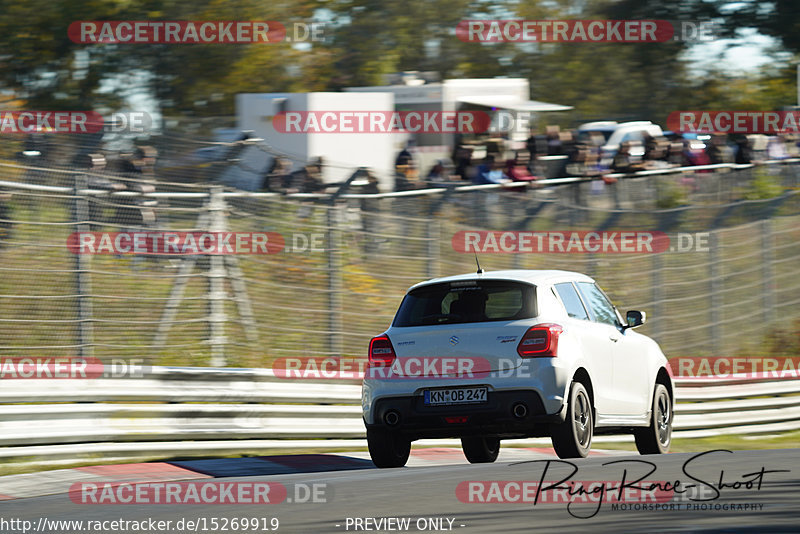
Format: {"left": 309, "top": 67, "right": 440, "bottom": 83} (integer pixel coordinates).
{"left": 365, "top": 390, "right": 565, "bottom": 439}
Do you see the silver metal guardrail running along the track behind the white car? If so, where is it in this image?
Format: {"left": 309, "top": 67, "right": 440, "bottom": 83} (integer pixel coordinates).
{"left": 0, "top": 367, "right": 800, "bottom": 471}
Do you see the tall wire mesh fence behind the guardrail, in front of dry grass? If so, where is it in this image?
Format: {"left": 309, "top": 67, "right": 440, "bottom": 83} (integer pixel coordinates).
{"left": 0, "top": 162, "right": 800, "bottom": 367}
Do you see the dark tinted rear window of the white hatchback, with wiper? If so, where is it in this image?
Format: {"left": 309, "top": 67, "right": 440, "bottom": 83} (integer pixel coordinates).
{"left": 392, "top": 280, "right": 536, "bottom": 326}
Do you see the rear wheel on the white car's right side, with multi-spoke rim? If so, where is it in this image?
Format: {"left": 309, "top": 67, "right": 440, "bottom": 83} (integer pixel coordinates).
{"left": 551, "top": 382, "right": 594, "bottom": 458}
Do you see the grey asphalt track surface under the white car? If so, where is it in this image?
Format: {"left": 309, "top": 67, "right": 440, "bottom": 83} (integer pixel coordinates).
{"left": 0, "top": 449, "right": 800, "bottom": 534}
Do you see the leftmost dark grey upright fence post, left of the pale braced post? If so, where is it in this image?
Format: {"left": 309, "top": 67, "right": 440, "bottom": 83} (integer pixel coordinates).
{"left": 73, "top": 174, "right": 94, "bottom": 358}
